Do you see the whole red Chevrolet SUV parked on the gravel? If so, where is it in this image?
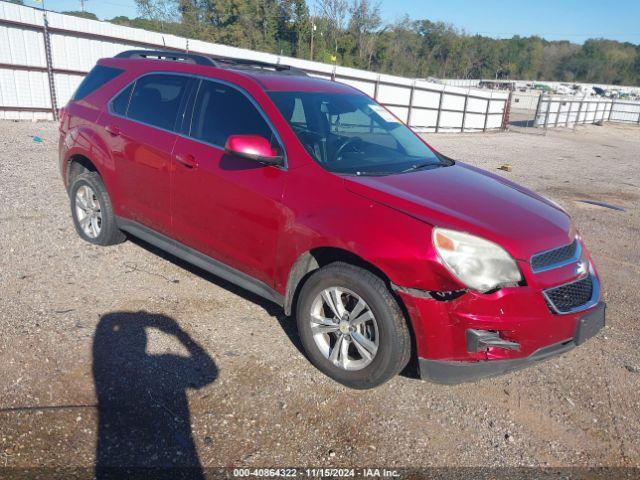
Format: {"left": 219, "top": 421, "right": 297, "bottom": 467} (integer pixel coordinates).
{"left": 60, "top": 51, "right": 605, "bottom": 388}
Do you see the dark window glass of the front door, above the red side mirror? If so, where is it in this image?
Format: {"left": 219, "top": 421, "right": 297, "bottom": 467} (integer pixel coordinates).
{"left": 191, "top": 80, "right": 274, "bottom": 147}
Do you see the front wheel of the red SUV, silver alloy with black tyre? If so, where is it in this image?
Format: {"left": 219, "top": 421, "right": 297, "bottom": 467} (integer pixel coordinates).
{"left": 296, "top": 262, "right": 411, "bottom": 389}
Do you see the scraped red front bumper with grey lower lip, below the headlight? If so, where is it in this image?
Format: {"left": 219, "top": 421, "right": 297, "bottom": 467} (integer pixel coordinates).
{"left": 394, "top": 287, "right": 605, "bottom": 384}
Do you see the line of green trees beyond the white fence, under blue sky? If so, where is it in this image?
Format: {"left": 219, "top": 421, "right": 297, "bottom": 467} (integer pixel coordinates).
{"left": 43, "top": 0, "right": 640, "bottom": 85}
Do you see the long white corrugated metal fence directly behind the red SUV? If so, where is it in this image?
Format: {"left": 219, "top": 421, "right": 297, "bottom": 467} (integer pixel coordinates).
{"left": 0, "top": 2, "right": 508, "bottom": 132}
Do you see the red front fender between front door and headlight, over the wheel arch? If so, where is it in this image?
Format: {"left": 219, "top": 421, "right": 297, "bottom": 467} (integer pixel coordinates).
{"left": 274, "top": 165, "right": 464, "bottom": 308}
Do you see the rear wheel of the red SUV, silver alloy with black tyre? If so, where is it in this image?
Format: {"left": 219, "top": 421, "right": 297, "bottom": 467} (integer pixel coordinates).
{"left": 69, "top": 172, "right": 127, "bottom": 246}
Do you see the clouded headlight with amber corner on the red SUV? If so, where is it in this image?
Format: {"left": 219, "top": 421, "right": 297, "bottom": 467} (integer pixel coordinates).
{"left": 433, "top": 228, "right": 522, "bottom": 292}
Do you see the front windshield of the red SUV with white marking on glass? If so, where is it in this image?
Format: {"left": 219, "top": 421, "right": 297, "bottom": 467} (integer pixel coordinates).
{"left": 269, "top": 92, "right": 451, "bottom": 175}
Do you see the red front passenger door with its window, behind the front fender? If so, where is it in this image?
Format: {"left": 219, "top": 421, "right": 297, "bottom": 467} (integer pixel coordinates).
{"left": 172, "top": 79, "right": 287, "bottom": 285}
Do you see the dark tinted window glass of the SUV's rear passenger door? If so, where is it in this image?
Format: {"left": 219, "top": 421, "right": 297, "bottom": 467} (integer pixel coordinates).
{"left": 127, "top": 75, "right": 189, "bottom": 130}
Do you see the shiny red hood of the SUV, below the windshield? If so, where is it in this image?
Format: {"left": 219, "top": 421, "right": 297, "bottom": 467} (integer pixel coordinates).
{"left": 344, "top": 163, "right": 575, "bottom": 260}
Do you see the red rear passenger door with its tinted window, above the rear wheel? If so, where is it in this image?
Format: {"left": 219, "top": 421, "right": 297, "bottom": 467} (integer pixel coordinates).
{"left": 100, "top": 73, "right": 195, "bottom": 235}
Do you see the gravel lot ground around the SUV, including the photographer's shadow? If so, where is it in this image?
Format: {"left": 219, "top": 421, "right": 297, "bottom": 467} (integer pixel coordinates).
{"left": 0, "top": 122, "right": 640, "bottom": 476}
